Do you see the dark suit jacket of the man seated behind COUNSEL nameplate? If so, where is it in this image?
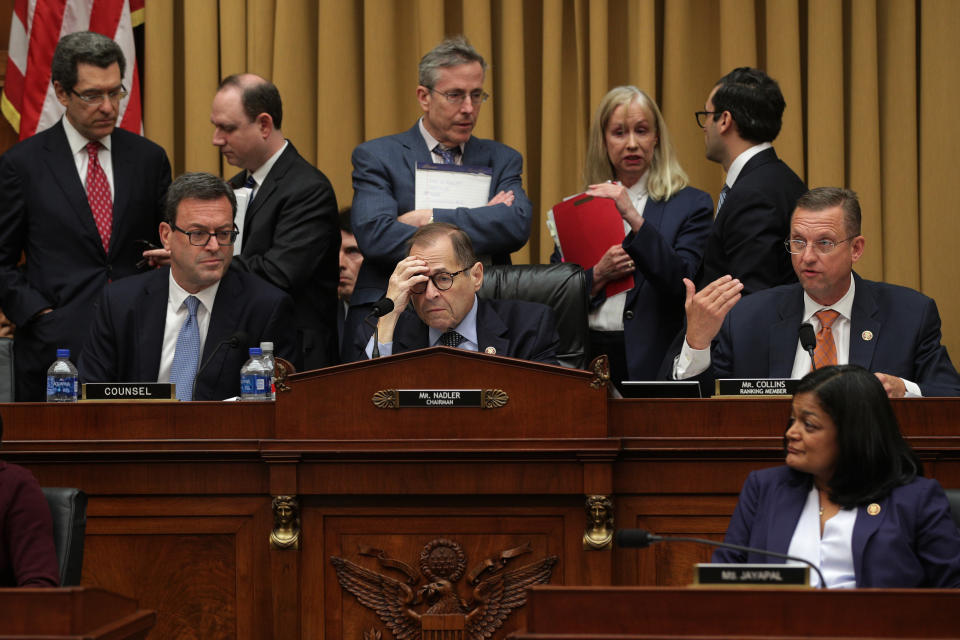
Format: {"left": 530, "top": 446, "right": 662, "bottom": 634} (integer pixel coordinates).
{"left": 77, "top": 267, "right": 300, "bottom": 400}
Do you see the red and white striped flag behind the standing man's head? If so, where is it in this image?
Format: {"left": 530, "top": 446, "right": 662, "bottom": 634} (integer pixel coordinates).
{"left": 0, "top": 0, "right": 144, "bottom": 140}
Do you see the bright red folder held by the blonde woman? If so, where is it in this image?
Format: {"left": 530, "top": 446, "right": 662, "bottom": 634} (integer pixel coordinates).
{"left": 553, "top": 193, "right": 633, "bottom": 298}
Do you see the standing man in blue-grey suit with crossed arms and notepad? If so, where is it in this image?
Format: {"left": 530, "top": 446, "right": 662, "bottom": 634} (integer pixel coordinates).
{"left": 342, "top": 36, "right": 532, "bottom": 360}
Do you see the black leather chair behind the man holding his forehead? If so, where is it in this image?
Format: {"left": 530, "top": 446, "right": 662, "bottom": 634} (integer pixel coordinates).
{"left": 477, "top": 262, "right": 590, "bottom": 369}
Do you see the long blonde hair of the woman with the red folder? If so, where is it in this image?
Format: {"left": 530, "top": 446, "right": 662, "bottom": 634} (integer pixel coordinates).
{"left": 583, "top": 85, "right": 690, "bottom": 200}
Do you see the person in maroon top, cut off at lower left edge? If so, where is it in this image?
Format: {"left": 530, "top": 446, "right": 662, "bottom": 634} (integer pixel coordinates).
{"left": 0, "top": 412, "right": 60, "bottom": 587}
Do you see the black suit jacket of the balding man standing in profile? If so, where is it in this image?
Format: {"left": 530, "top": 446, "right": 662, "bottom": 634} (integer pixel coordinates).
{"left": 230, "top": 144, "right": 340, "bottom": 369}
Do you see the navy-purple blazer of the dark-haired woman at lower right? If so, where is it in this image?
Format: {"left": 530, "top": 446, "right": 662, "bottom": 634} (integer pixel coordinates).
{"left": 713, "top": 467, "right": 960, "bottom": 589}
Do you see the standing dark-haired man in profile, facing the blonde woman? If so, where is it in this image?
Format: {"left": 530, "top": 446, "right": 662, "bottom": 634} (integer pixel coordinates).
{"left": 695, "top": 67, "right": 807, "bottom": 295}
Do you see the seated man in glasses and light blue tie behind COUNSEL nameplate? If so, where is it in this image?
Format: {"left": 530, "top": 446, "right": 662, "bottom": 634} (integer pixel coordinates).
{"left": 77, "top": 173, "right": 300, "bottom": 401}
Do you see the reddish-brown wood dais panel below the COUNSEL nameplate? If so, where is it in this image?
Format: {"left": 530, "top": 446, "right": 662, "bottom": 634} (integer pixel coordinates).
{"left": 83, "top": 497, "right": 272, "bottom": 640}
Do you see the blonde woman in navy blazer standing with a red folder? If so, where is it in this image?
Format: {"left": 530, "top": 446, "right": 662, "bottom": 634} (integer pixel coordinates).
{"left": 553, "top": 86, "right": 713, "bottom": 383}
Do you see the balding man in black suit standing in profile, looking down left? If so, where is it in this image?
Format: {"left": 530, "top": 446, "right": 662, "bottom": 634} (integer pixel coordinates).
{"left": 210, "top": 73, "right": 340, "bottom": 369}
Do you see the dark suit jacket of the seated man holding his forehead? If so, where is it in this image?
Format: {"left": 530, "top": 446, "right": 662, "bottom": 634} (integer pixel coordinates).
{"left": 355, "top": 298, "right": 560, "bottom": 364}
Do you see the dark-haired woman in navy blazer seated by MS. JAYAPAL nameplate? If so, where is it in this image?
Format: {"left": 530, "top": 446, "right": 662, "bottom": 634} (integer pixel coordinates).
{"left": 713, "top": 365, "right": 960, "bottom": 588}
